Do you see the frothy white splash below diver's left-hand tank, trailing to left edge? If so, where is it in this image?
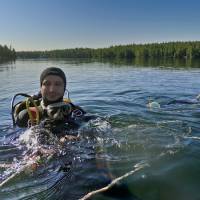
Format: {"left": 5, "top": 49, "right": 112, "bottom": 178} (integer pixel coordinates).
{"left": 0, "top": 126, "right": 63, "bottom": 187}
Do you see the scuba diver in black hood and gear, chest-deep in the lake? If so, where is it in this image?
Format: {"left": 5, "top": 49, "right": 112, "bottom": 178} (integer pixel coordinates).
{"left": 12, "top": 67, "right": 90, "bottom": 136}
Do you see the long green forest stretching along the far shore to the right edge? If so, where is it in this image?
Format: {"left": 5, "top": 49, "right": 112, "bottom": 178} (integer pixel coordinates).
{"left": 17, "top": 41, "right": 200, "bottom": 59}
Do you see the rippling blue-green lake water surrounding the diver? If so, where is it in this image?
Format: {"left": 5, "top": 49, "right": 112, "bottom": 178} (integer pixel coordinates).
{"left": 0, "top": 60, "right": 200, "bottom": 200}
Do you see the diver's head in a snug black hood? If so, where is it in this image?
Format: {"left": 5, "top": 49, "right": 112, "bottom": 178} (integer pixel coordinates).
{"left": 40, "top": 67, "right": 67, "bottom": 105}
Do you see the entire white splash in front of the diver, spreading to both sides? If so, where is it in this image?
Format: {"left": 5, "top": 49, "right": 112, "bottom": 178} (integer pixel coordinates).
{"left": 0, "top": 118, "right": 111, "bottom": 187}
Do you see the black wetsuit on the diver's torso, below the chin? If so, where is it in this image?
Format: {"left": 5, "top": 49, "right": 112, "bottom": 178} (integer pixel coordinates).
{"left": 14, "top": 99, "right": 92, "bottom": 136}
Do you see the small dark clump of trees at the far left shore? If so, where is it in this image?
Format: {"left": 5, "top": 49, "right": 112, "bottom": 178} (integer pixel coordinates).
{"left": 0, "top": 45, "right": 16, "bottom": 61}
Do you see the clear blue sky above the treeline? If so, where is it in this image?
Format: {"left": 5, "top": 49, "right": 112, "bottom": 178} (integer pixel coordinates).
{"left": 0, "top": 0, "right": 200, "bottom": 51}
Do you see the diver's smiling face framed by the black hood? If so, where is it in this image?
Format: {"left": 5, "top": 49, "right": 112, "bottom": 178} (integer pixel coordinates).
{"left": 40, "top": 75, "right": 65, "bottom": 101}
